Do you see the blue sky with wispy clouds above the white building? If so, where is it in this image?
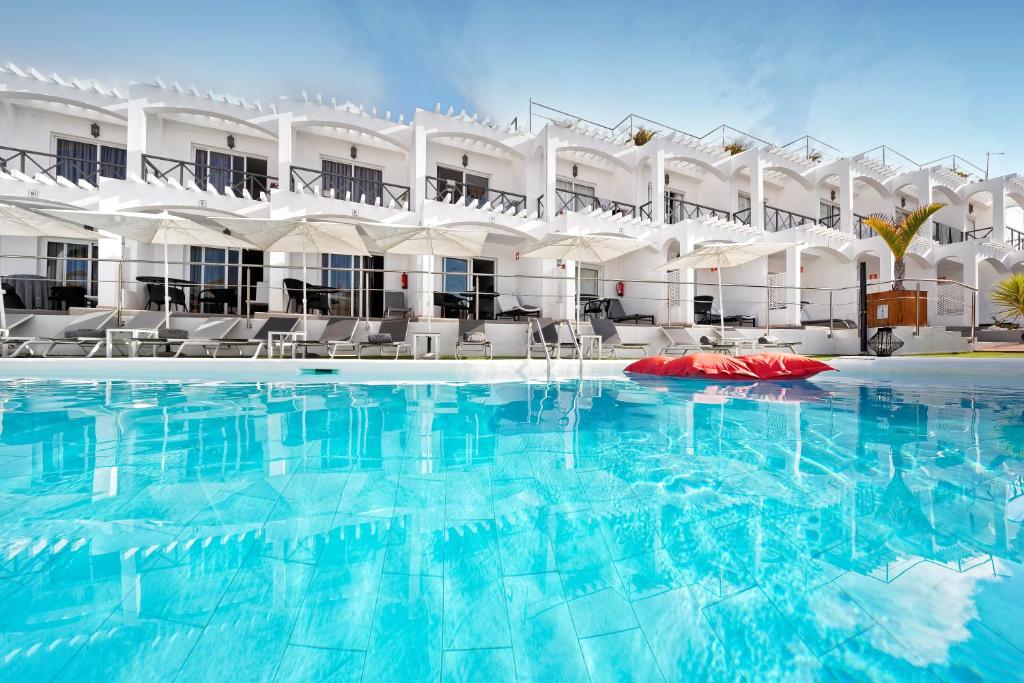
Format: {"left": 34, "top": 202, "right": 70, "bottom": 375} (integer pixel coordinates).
{"left": 8, "top": 0, "right": 1024, "bottom": 173}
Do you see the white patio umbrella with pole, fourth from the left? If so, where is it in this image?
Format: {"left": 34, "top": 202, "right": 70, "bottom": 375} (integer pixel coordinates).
{"left": 359, "top": 222, "right": 491, "bottom": 331}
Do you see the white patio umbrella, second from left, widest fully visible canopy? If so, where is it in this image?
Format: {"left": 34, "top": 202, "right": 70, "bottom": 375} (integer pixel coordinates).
{"left": 46, "top": 210, "right": 255, "bottom": 327}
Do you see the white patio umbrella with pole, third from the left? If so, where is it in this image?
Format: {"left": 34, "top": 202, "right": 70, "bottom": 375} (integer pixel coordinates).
{"left": 208, "top": 217, "right": 370, "bottom": 332}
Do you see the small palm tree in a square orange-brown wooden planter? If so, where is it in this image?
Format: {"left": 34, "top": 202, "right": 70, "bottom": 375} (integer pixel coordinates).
{"left": 864, "top": 203, "right": 945, "bottom": 328}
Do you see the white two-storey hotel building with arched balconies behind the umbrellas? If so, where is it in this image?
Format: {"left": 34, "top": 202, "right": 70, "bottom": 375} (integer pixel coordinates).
{"left": 0, "top": 63, "right": 1024, "bottom": 351}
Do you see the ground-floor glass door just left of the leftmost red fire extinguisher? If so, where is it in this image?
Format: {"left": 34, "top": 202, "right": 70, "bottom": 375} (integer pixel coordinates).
{"left": 321, "top": 254, "right": 384, "bottom": 317}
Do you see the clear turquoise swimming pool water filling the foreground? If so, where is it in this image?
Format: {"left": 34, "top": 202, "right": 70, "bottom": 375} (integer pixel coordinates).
{"left": 0, "top": 380, "right": 1024, "bottom": 683}
